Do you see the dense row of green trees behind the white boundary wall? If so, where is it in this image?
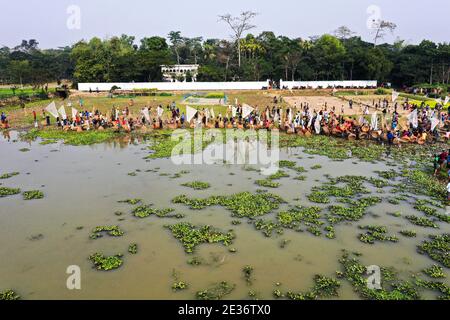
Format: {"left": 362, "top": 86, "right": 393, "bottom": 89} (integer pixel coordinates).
{"left": 0, "top": 25, "right": 450, "bottom": 87}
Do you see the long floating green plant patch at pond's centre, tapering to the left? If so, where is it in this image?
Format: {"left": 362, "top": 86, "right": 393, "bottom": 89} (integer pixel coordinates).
{"left": 172, "top": 192, "right": 284, "bottom": 218}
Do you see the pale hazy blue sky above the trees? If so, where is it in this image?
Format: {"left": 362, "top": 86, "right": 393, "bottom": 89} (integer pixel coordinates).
{"left": 0, "top": 0, "right": 450, "bottom": 48}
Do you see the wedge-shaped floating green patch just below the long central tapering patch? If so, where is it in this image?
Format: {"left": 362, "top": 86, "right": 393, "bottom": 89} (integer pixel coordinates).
{"left": 166, "top": 222, "right": 235, "bottom": 253}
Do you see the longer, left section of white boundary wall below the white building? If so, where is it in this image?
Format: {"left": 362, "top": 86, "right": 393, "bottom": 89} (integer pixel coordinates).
{"left": 78, "top": 80, "right": 269, "bottom": 91}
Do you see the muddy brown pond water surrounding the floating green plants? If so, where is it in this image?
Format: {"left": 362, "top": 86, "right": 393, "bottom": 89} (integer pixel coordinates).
{"left": 0, "top": 132, "right": 449, "bottom": 299}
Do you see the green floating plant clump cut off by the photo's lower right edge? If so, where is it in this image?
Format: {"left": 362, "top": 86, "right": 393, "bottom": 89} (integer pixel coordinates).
{"left": 417, "top": 233, "right": 450, "bottom": 268}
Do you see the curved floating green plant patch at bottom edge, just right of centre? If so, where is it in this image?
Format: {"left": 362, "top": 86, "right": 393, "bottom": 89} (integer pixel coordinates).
{"left": 284, "top": 275, "right": 341, "bottom": 300}
